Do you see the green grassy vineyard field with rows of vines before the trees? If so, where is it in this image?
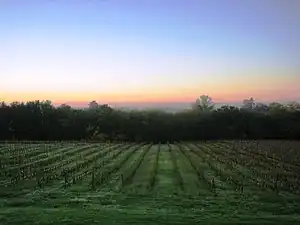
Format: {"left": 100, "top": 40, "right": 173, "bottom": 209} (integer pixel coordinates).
{"left": 0, "top": 141, "right": 300, "bottom": 225}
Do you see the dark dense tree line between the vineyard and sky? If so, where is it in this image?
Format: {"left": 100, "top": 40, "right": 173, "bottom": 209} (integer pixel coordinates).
{"left": 0, "top": 95, "right": 300, "bottom": 142}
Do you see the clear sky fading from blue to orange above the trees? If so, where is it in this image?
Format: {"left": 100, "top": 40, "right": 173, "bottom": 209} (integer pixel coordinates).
{"left": 0, "top": 0, "right": 300, "bottom": 105}
